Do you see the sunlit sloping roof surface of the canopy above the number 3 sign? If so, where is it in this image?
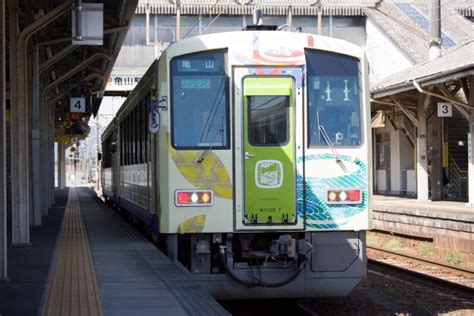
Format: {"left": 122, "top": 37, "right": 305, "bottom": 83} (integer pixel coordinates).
{"left": 370, "top": 40, "right": 474, "bottom": 98}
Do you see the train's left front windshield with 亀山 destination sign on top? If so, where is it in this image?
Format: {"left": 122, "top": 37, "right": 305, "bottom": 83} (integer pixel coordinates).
{"left": 171, "top": 51, "right": 229, "bottom": 149}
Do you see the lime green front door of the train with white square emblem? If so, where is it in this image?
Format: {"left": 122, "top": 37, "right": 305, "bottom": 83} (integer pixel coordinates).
{"left": 243, "top": 77, "right": 296, "bottom": 225}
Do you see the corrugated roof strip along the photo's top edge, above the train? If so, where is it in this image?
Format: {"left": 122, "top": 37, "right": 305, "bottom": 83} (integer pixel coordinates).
{"left": 136, "top": 0, "right": 375, "bottom": 16}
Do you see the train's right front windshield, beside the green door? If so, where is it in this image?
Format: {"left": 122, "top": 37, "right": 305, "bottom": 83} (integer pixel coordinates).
{"left": 306, "top": 50, "right": 361, "bottom": 147}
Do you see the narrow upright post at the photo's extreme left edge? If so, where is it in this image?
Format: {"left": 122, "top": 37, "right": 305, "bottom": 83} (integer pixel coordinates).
{"left": 0, "top": 1, "right": 8, "bottom": 282}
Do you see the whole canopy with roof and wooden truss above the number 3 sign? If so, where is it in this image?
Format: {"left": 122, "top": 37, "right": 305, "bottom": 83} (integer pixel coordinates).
{"left": 371, "top": 39, "right": 474, "bottom": 123}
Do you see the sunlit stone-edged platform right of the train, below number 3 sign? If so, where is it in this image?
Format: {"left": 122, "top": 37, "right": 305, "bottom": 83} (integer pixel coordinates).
{"left": 372, "top": 195, "right": 474, "bottom": 258}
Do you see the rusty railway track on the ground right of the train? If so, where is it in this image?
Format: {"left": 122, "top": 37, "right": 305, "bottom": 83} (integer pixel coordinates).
{"left": 367, "top": 246, "right": 474, "bottom": 293}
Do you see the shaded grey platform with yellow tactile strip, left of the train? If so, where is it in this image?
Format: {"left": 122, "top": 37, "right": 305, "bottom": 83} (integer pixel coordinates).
{"left": 0, "top": 188, "right": 228, "bottom": 316}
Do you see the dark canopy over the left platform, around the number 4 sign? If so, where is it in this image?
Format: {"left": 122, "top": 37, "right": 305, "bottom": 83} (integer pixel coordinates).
{"left": 6, "top": 0, "right": 138, "bottom": 142}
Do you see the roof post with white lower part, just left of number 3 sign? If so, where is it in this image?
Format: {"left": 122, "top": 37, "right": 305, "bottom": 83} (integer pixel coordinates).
{"left": 416, "top": 96, "right": 430, "bottom": 201}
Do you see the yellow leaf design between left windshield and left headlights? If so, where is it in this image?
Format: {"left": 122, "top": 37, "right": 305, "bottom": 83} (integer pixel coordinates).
{"left": 168, "top": 138, "right": 232, "bottom": 199}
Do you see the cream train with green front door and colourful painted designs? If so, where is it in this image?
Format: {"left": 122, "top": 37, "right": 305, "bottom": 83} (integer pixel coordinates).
{"left": 101, "top": 29, "right": 372, "bottom": 299}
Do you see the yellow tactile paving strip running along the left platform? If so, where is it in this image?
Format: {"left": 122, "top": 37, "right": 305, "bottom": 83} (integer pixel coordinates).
{"left": 43, "top": 188, "right": 104, "bottom": 316}
